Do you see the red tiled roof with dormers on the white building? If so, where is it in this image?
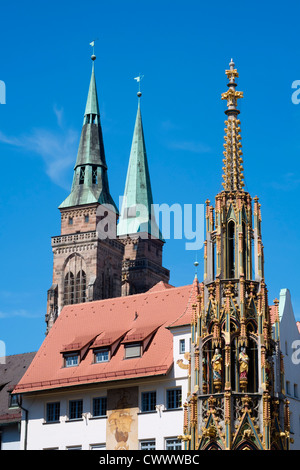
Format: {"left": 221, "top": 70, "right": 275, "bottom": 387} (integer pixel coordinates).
{"left": 14, "top": 282, "right": 196, "bottom": 393}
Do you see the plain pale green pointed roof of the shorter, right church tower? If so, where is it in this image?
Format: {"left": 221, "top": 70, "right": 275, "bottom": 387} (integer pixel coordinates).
{"left": 118, "top": 96, "right": 163, "bottom": 241}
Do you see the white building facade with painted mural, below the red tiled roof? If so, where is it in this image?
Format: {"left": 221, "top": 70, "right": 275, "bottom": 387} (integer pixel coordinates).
{"left": 20, "top": 325, "right": 190, "bottom": 450}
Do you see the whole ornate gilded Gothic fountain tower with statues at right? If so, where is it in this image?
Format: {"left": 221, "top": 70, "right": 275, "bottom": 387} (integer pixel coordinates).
{"left": 182, "top": 60, "right": 289, "bottom": 450}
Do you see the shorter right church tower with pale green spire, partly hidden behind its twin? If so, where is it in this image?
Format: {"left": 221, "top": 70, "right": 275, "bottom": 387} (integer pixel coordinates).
{"left": 118, "top": 91, "right": 170, "bottom": 295}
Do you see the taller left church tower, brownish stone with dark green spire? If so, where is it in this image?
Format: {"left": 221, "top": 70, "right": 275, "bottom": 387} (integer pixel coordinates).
{"left": 46, "top": 54, "right": 124, "bottom": 332}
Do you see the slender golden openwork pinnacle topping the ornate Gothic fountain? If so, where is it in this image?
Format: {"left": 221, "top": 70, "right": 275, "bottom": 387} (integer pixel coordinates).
{"left": 222, "top": 59, "right": 244, "bottom": 191}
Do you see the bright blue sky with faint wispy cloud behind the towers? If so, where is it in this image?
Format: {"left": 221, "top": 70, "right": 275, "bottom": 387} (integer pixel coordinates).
{"left": 0, "top": 0, "right": 300, "bottom": 354}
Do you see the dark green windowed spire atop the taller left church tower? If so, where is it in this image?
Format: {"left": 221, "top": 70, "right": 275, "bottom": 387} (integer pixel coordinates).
{"left": 59, "top": 54, "right": 117, "bottom": 210}
